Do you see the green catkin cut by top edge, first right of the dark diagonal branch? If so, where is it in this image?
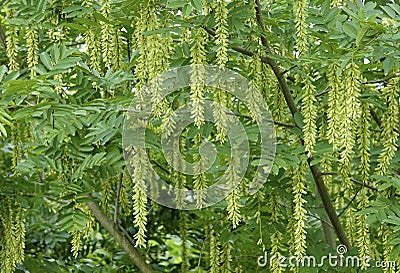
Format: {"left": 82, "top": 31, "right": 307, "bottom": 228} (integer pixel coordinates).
{"left": 295, "top": 0, "right": 308, "bottom": 56}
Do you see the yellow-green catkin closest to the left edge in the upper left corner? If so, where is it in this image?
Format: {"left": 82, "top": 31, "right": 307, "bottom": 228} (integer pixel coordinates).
{"left": 6, "top": 11, "right": 19, "bottom": 73}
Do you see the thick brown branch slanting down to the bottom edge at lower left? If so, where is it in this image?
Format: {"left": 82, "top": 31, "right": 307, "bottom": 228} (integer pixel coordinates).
{"left": 86, "top": 194, "right": 154, "bottom": 273}
